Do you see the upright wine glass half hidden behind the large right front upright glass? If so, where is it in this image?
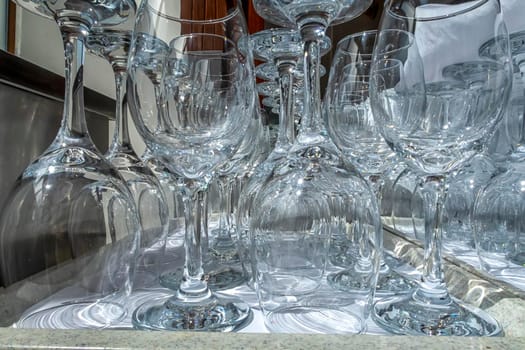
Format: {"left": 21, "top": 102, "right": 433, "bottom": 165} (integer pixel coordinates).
{"left": 323, "top": 30, "right": 414, "bottom": 295}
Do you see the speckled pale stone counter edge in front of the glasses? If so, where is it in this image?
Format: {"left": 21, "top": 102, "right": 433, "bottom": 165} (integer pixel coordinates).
{"left": 0, "top": 328, "right": 525, "bottom": 350}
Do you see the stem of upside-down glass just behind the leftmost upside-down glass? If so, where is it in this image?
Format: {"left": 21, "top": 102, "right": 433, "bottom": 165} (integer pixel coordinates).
{"left": 108, "top": 69, "right": 132, "bottom": 154}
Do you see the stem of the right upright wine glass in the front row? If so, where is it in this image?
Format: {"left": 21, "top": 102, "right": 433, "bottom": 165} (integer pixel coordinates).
{"left": 414, "top": 175, "right": 450, "bottom": 304}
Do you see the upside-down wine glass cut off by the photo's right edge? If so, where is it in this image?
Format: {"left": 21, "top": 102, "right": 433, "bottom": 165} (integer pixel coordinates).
{"left": 473, "top": 31, "right": 525, "bottom": 287}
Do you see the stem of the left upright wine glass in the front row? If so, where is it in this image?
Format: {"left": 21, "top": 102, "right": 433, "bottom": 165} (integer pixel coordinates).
{"left": 177, "top": 183, "right": 211, "bottom": 302}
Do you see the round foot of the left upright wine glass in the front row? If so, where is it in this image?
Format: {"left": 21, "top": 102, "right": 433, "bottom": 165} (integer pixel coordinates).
{"left": 132, "top": 294, "right": 253, "bottom": 332}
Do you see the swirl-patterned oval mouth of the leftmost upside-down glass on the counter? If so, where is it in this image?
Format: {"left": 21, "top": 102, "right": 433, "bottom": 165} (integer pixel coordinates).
{"left": 14, "top": 302, "right": 126, "bottom": 329}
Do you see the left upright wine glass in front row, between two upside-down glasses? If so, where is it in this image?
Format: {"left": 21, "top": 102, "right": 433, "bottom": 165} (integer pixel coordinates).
{"left": 128, "top": 0, "right": 254, "bottom": 331}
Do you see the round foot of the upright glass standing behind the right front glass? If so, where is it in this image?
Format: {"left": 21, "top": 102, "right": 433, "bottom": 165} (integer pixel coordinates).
{"left": 327, "top": 269, "right": 417, "bottom": 296}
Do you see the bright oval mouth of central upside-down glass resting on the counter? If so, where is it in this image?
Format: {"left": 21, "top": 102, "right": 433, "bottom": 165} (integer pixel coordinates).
{"left": 264, "top": 306, "right": 365, "bottom": 334}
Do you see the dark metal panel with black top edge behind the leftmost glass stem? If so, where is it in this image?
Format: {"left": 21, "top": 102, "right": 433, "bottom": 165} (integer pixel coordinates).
{"left": 0, "top": 51, "right": 115, "bottom": 288}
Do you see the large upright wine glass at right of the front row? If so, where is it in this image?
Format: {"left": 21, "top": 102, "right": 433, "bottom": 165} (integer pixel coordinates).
{"left": 370, "top": 0, "right": 512, "bottom": 335}
